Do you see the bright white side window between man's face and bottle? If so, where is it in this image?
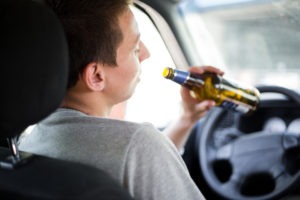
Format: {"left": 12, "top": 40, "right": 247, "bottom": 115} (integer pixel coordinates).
{"left": 119, "top": 8, "right": 180, "bottom": 128}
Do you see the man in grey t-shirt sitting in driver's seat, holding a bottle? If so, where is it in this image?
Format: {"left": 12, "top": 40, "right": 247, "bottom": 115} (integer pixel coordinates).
{"left": 20, "top": 0, "right": 222, "bottom": 200}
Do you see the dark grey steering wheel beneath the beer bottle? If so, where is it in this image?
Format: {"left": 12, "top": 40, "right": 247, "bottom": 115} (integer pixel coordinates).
{"left": 198, "top": 86, "right": 300, "bottom": 200}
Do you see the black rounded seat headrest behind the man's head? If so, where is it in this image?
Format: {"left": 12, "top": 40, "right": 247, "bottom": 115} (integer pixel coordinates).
{"left": 0, "top": 0, "right": 68, "bottom": 138}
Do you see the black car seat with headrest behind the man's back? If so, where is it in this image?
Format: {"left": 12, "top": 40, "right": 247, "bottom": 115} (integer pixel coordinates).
{"left": 0, "top": 0, "right": 131, "bottom": 200}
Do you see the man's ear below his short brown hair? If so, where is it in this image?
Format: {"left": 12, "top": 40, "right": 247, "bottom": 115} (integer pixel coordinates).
{"left": 82, "top": 62, "right": 105, "bottom": 91}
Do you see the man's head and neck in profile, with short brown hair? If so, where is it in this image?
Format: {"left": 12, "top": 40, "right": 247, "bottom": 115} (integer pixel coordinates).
{"left": 46, "top": 0, "right": 149, "bottom": 116}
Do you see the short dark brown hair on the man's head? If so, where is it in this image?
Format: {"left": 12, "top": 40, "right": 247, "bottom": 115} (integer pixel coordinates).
{"left": 46, "top": 0, "right": 132, "bottom": 88}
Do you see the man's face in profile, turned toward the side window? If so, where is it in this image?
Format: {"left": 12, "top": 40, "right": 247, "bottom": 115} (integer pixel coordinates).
{"left": 103, "top": 9, "right": 150, "bottom": 104}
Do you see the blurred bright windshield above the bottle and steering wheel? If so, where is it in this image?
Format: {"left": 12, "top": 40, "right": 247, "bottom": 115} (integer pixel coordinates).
{"left": 180, "top": 0, "right": 300, "bottom": 91}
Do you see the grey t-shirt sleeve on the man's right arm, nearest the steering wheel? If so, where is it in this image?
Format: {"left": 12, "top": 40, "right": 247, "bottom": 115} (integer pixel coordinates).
{"left": 123, "top": 124, "right": 204, "bottom": 200}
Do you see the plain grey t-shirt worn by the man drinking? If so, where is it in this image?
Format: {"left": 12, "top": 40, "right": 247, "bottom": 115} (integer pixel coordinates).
{"left": 19, "top": 108, "right": 204, "bottom": 200}
